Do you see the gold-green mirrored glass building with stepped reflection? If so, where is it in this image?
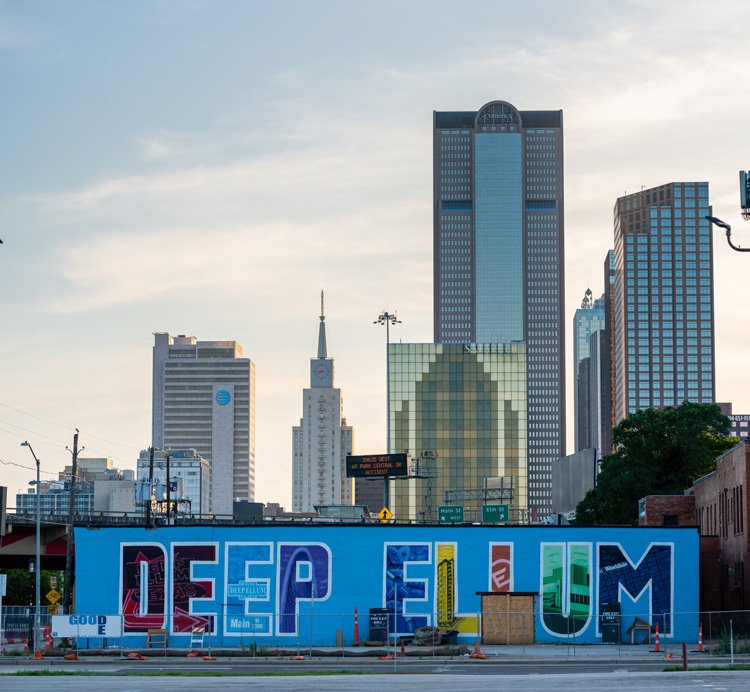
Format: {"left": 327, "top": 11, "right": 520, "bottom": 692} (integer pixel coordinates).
{"left": 388, "top": 343, "right": 528, "bottom": 521}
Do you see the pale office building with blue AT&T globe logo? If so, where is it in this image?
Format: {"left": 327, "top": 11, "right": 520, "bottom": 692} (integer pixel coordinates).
{"left": 151, "top": 333, "right": 255, "bottom": 516}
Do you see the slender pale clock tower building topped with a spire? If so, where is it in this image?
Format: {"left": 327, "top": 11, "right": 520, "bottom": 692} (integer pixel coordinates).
{"left": 292, "top": 292, "right": 354, "bottom": 512}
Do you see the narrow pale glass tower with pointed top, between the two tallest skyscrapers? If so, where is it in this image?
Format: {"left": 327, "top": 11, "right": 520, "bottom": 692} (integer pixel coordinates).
{"left": 573, "top": 288, "right": 604, "bottom": 452}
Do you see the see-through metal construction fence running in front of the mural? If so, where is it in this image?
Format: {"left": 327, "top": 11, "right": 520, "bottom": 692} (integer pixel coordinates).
{"left": 0, "top": 604, "right": 750, "bottom": 656}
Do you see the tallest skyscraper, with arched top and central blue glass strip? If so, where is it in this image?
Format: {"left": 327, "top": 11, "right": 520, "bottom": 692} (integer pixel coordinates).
{"left": 433, "top": 101, "right": 565, "bottom": 519}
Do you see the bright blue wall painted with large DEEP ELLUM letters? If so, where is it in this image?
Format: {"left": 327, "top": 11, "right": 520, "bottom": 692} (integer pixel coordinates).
{"left": 75, "top": 525, "right": 698, "bottom": 646}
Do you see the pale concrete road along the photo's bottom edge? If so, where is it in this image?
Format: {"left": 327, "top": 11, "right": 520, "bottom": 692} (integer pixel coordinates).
{"left": 0, "top": 669, "right": 750, "bottom": 692}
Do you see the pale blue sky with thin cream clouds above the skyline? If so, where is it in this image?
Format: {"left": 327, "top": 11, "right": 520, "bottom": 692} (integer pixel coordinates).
{"left": 0, "top": 0, "right": 750, "bottom": 507}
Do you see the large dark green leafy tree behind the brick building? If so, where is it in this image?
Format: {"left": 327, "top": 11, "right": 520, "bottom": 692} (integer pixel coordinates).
{"left": 576, "top": 401, "right": 737, "bottom": 526}
